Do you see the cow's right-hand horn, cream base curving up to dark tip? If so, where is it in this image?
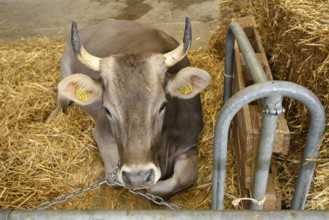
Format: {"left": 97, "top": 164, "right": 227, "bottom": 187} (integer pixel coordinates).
{"left": 164, "top": 17, "right": 192, "bottom": 67}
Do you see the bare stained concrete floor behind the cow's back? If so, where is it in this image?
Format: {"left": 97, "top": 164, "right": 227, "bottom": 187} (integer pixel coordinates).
{"left": 0, "top": 0, "right": 220, "bottom": 49}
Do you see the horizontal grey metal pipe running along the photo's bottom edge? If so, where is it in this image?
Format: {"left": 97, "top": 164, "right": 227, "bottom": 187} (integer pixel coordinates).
{"left": 0, "top": 210, "right": 329, "bottom": 220}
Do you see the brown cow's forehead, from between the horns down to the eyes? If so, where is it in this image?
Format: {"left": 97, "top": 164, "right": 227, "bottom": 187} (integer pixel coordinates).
{"left": 101, "top": 54, "right": 167, "bottom": 108}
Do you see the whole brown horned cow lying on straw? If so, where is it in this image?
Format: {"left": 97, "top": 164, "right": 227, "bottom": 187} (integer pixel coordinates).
{"left": 49, "top": 18, "right": 211, "bottom": 197}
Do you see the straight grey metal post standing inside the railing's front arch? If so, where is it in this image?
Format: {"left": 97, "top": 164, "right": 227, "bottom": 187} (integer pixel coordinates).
{"left": 250, "top": 112, "right": 278, "bottom": 210}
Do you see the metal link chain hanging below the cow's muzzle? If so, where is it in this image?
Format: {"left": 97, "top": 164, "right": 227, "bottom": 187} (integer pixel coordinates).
{"left": 34, "top": 162, "right": 182, "bottom": 210}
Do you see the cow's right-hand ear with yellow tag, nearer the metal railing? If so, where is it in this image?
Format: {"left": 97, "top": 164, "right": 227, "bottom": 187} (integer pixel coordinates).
{"left": 166, "top": 67, "right": 211, "bottom": 99}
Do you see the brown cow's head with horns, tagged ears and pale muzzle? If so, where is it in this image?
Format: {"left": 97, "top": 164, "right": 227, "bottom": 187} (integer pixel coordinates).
{"left": 58, "top": 19, "right": 210, "bottom": 188}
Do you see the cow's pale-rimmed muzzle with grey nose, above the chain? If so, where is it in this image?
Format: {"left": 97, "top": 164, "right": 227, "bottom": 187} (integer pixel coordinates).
{"left": 118, "top": 163, "right": 161, "bottom": 189}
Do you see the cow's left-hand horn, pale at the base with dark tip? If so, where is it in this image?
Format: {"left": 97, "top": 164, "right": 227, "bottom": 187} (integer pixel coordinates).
{"left": 71, "top": 21, "right": 101, "bottom": 71}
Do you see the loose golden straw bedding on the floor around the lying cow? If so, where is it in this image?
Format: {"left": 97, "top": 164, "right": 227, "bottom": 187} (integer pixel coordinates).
{"left": 0, "top": 38, "right": 233, "bottom": 209}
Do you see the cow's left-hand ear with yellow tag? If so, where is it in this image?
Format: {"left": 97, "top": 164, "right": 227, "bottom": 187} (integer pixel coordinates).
{"left": 58, "top": 73, "right": 102, "bottom": 105}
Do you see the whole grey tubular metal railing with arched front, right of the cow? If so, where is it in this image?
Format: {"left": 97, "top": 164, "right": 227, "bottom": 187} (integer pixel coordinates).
{"left": 212, "top": 22, "right": 326, "bottom": 210}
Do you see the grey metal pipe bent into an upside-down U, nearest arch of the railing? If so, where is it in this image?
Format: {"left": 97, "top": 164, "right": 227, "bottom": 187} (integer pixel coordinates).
{"left": 212, "top": 81, "right": 326, "bottom": 210}
